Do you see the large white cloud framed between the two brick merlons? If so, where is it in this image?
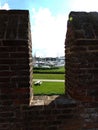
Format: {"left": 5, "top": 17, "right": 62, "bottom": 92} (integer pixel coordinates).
{"left": 32, "top": 8, "right": 67, "bottom": 56}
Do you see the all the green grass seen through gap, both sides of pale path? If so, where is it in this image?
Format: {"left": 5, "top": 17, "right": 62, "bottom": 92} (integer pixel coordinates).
{"left": 33, "top": 67, "right": 65, "bottom": 95}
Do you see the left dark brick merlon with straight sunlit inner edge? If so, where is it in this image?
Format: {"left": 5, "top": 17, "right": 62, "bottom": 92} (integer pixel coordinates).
{"left": 0, "top": 10, "right": 32, "bottom": 105}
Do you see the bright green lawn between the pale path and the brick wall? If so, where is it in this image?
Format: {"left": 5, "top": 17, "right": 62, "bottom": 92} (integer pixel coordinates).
{"left": 33, "top": 82, "right": 65, "bottom": 95}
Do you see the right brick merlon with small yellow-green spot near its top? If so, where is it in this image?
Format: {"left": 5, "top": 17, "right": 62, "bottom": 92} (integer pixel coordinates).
{"left": 65, "top": 12, "right": 98, "bottom": 102}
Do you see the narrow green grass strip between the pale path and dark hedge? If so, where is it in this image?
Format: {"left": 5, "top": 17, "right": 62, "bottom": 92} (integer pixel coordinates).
{"left": 33, "top": 74, "right": 64, "bottom": 80}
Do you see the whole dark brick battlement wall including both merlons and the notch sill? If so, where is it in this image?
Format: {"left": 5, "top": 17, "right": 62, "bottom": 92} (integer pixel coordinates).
{"left": 0, "top": 10, "right": 98, "bottom": 130}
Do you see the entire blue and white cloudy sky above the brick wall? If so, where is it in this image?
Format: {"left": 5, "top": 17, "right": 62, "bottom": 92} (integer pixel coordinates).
{"left": 0, "top": 0, "right": 98, "bottom": 57}
